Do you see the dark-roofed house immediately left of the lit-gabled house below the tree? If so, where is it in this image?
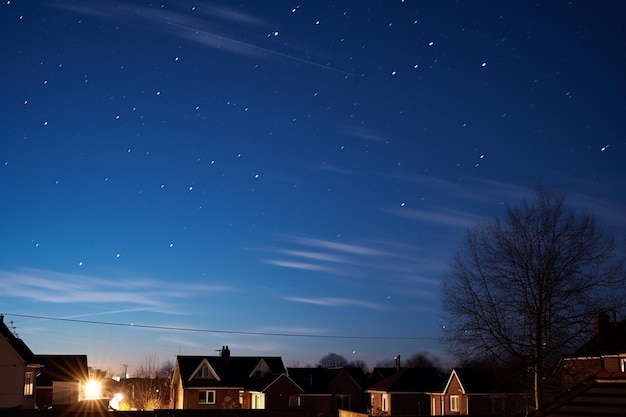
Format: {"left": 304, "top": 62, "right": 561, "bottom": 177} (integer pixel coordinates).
{"left": 366, "top": 368, "right": 445, "bottom": 416}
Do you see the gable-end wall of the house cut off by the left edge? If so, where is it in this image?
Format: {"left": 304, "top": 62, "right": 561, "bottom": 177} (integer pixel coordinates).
{"left": 0, "top": 337, "right": 35, "bottom": 408}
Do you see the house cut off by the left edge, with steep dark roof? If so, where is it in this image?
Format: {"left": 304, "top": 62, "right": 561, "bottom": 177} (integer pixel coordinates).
{"left": 0, "top": 314, "right": 41, "bottom": 409}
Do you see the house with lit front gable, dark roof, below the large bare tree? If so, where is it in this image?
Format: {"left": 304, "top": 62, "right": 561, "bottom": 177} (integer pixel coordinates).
{"left": 430, "top": 368, "right": 533, "bottom": 416}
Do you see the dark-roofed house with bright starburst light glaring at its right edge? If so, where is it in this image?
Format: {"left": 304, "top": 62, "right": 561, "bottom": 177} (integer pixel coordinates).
{"left": 35, "top": 355, "right": 89, "bottom": 410}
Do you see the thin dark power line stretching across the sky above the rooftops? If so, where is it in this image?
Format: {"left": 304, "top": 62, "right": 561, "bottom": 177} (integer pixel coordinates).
{"left": 4, "top": 313, "right": 436, "bottom": 340}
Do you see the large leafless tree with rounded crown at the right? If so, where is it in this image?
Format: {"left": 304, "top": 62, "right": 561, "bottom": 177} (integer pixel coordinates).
{"left": 442, "top": 185, "right": 625, "bottom": 408}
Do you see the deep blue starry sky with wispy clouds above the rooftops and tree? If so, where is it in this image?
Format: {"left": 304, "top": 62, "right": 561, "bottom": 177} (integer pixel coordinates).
{"left": 0, "top": 0, "right": 626, "bottom": 372}
